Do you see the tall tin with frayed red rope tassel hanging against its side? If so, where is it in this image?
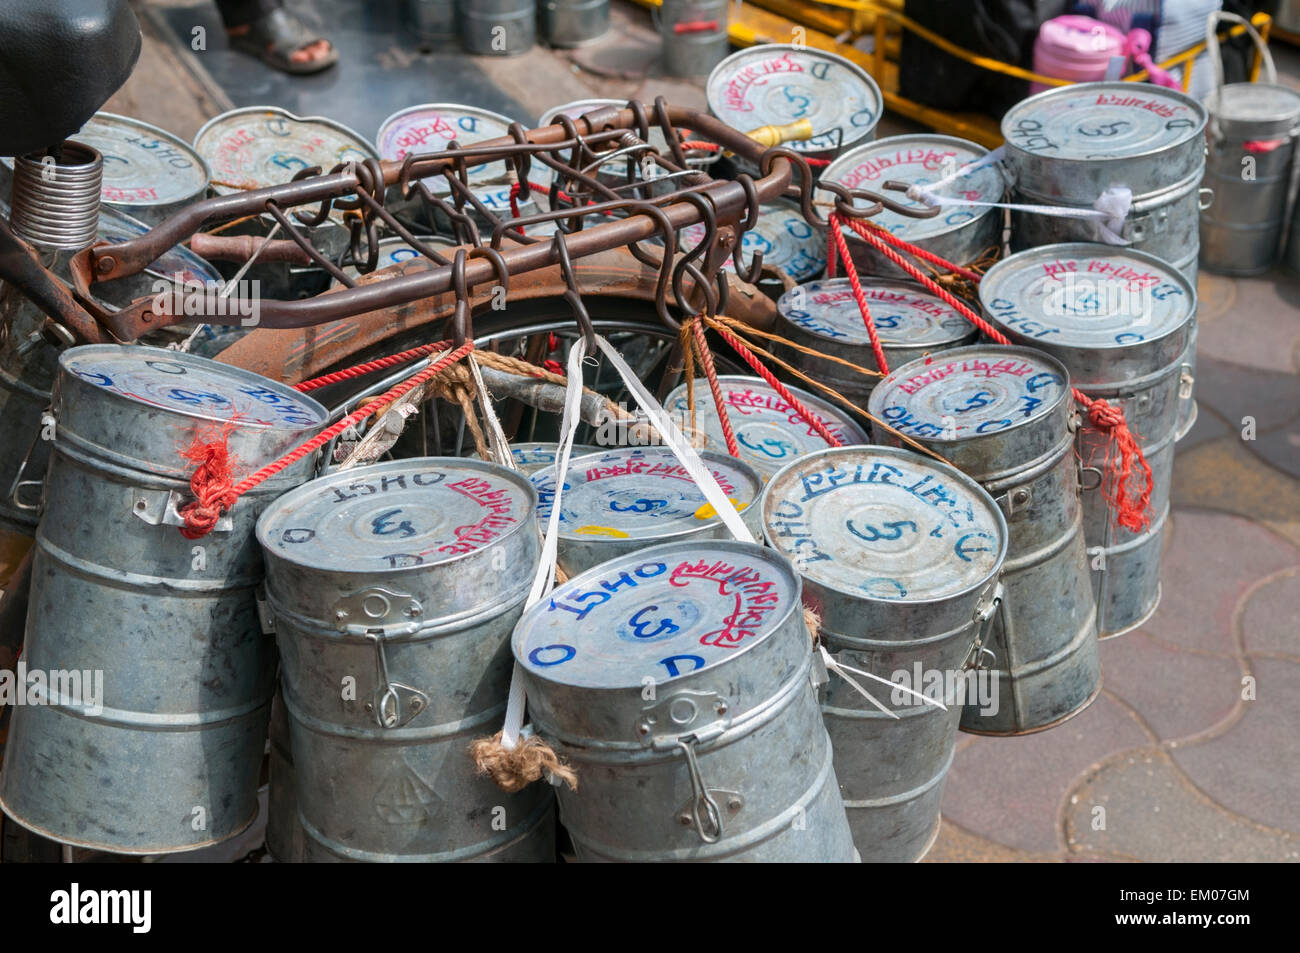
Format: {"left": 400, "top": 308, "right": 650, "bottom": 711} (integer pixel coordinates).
{"left": 980, "top": 243, "right": 1196, "bottom": 638}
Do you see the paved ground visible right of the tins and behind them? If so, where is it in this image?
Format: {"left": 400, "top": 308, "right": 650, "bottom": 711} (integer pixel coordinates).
{"left": 108, "top": 0, "right": 1300, "bottom": 862}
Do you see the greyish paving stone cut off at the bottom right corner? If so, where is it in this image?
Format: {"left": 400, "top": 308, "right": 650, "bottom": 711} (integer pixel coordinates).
{"left": 1065, "top": 751, "right": 1300, "bottom": 863}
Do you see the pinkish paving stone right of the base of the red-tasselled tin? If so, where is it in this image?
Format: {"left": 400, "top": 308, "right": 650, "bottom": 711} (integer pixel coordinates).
{"left": 1149, "top": 507, "right": 1300, "bottom": 654}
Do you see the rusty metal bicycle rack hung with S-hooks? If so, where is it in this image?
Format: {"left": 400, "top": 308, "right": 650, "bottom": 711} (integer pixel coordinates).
{"left": 7, "top": 98, "right": 937, "bottom": 356}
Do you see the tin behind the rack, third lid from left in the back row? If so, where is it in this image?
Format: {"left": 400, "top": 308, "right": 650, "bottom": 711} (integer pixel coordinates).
{"left": 374, "top": 103, "right": 551, "bottom": 230}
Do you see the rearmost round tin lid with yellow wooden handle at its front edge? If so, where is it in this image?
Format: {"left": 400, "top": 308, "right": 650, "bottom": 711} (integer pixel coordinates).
{"left": 705, "top": 43, "right": 884, "bottom": 172}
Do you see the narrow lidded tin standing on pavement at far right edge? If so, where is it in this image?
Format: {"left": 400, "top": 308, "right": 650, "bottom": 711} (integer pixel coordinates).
{"left": 1200, "top": 83, "right": 1300, "bottom": 274}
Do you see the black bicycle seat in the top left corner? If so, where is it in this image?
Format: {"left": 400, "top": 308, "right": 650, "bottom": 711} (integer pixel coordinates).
{"left": 0, "top": 0, "right": 140, "bottom": 156}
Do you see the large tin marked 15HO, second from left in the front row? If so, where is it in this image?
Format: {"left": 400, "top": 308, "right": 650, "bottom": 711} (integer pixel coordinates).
{"left": 257, "top": 458, "right": 555, "bottom": 862}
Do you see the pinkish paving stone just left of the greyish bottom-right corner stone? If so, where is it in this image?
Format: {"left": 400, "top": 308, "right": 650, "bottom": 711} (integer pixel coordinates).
{"left": 943, "top": 692, "right": 1151, "bottom": 854}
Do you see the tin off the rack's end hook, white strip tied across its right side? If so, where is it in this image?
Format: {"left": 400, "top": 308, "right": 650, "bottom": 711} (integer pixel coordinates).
{"left": 822, "top": 133, "right": 1006, "bottom": 278}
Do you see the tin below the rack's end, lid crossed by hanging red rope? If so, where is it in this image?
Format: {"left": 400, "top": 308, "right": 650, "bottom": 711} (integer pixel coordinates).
{"left": 776, "top": 278, "right": 979, "bottom": 406}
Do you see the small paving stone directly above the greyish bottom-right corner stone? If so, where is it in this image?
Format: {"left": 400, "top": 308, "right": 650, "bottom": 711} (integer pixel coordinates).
{"left": 1101, "top": 631, "right": 1242, "bottom": 741}
